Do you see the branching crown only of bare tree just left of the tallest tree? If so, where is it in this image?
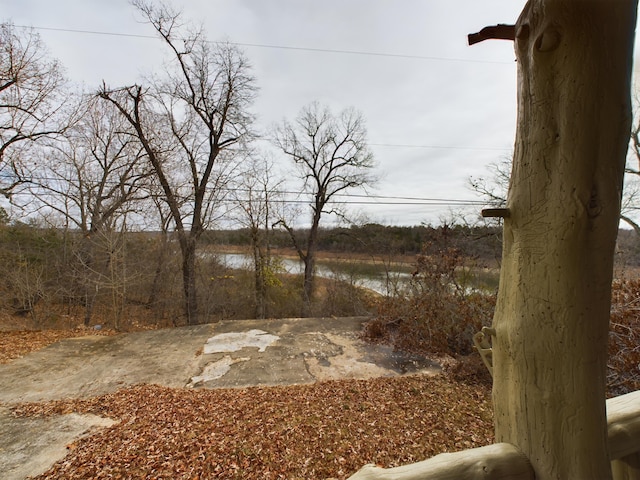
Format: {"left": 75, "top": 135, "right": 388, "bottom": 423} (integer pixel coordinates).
{"left": 29, "top": 98, "right": 150, "bottom": 236}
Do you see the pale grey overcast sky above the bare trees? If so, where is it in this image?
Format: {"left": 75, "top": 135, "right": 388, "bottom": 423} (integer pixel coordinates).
{"left": 5, "top": 0, "right": 640, "bottom": 225}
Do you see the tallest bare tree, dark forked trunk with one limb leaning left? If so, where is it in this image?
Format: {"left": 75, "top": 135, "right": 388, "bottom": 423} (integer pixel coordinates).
{"left": 99, "top": 0, "right": 255, "bottom": 324}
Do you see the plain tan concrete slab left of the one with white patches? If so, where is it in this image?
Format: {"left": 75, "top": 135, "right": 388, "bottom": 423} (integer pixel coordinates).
{"left": 0, "top": 325, "right": 215, "bottom": 403}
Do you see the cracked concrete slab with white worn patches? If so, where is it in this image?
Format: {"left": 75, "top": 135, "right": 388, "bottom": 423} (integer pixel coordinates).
{"left": 189, "top": 317, "right": 439, "bottom": 388}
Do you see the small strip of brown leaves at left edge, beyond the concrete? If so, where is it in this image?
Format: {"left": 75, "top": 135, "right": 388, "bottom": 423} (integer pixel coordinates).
{"left": 0, "top": 328, "right": 115, "bottom": 364}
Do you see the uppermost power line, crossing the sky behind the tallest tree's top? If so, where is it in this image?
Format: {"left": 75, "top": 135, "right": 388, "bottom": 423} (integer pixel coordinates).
{"left": 16, "top": 25, "right": 513, "bottom": 65}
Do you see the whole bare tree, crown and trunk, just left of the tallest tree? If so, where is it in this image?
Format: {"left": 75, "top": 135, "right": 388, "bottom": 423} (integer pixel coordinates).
{"left": 28, "top": 97, "right": 149, "bottom": 325}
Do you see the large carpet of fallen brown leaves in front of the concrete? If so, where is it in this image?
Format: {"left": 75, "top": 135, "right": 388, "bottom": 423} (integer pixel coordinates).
{"left": 14, "top": 376, "right": 493, "bottom": 479}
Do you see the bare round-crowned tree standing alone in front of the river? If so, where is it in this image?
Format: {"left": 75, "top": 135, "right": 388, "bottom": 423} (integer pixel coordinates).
{"left": 275, "top": 102, "right": 374, "bottom": 315}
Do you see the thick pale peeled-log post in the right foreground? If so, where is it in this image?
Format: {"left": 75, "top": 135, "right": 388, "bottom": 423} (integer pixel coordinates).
{"left": 493, "top": 0, "right": 637, "bottom": 480}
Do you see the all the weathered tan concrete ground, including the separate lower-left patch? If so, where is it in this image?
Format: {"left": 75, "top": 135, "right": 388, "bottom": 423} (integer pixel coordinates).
{"left": 0, "top": 317, "right": 439, "bottom": 480}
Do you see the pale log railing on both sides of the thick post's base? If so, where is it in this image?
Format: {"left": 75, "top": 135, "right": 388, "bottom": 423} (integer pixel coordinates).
{"left": 349, "top": 390, "right": 640, "bottom": 480}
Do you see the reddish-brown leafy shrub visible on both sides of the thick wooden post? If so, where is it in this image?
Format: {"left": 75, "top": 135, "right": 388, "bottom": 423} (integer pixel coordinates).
{"left": 364, "top": 249, "right": 640, "bottom": 396}
